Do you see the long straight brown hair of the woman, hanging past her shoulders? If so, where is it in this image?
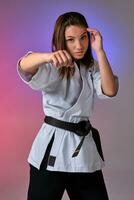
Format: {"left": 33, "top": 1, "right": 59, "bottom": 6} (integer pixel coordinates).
{"left": 52, "top": 12, "right": 94, "bottom": 79}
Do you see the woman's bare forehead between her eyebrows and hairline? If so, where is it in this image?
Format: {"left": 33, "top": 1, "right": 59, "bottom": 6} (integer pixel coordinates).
{"left": 65, "top": 25, "right": 87, "bottom": 37}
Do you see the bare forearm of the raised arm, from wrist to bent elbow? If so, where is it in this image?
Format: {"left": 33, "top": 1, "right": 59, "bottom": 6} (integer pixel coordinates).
{"left": 97, "top": 50, "right": 118, "bottom": 96}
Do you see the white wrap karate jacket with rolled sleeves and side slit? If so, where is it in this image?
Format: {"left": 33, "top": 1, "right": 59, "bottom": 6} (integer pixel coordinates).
{"left": 17, "top": 54, "right": 109, "bottom": 172}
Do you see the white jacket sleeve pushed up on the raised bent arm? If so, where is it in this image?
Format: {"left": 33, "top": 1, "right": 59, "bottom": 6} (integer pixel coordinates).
{"left": 92, "top": 60, "right": 112, "bottom": 99}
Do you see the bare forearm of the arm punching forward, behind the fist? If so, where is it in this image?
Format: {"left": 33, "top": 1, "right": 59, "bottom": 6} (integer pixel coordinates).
{"left": 20, "top": 53, "right": 47, "bottom": 74}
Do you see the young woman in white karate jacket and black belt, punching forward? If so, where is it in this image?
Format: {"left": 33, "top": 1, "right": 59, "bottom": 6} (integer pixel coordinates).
{"left": 18, "top": 12, "right": 118, "bottom": 200}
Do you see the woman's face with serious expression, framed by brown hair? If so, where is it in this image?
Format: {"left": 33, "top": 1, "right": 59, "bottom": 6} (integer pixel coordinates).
{"left": 65, "top": 25, "right": 89, "bottom": 60}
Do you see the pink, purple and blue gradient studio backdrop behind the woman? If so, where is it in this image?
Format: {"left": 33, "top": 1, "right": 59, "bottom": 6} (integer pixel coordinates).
{"left": 0, "top": 0, "right": 134, "bottom": 200}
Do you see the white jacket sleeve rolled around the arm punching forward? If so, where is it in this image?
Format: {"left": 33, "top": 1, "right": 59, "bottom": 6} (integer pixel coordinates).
{"left": 17, "top": 52, "right": 56, "bottom": 90}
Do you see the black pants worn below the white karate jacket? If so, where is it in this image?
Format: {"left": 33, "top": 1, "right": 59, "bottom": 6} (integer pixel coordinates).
{"left": 28, "top": 136, "right": 108, "bottom": 200}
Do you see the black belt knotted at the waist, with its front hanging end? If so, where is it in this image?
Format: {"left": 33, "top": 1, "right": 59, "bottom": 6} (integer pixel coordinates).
{"left": 44, "top": 116, "right": 92, "bottom": 157}
